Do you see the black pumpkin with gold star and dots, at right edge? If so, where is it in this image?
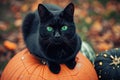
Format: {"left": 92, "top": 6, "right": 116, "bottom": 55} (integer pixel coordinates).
{"left": 95, "top": 48, "right": 120, "bottom": 80}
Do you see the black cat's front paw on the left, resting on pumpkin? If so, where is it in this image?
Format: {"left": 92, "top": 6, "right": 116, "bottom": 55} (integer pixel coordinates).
{"left": 48, "top": 63, "right": 60, "bottom": 74}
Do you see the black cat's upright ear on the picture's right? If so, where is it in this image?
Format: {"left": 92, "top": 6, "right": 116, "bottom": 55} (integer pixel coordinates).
{"left": 62, "top": 3, "right": 74, "bottom": 21}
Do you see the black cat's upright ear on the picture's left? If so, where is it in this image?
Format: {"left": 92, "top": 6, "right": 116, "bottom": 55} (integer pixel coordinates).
{"left": 38, "top": 4, "right": 52, "bottom": 22}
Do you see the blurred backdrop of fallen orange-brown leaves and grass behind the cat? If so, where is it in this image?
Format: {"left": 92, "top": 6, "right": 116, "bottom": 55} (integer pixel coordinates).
{"left": 0, "top": 0, "right": 120, "bottom": 74}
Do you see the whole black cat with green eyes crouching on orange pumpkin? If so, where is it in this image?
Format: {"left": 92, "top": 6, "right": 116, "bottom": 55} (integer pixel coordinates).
{"left": 22, "top": 3, "right": 81, "bottom": 74}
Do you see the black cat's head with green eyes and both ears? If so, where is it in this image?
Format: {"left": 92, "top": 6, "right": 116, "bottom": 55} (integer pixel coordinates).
{"left": 38, "top": 3, "right": 75, "bottom": 44}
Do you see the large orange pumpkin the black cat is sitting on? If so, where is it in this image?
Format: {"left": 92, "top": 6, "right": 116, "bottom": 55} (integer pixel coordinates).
{"left": 1, "top": 49, "right": 98, "bottom": 80}
